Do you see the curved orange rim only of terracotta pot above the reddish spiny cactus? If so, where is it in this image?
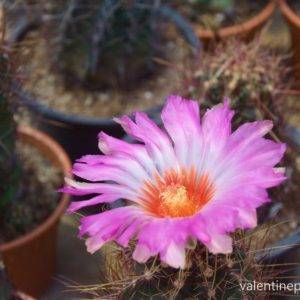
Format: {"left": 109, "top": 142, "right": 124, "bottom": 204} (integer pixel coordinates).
{"left": 195, "top": 0, "right": 277, "bottom": 40}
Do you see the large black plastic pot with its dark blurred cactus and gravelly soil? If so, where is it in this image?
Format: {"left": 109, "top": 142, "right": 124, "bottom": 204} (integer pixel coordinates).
{"left": 5, "top": 0, "right": 199, "bottom": 158}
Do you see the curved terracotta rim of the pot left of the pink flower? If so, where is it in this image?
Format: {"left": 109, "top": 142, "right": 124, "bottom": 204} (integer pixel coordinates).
{"left": 0, "top": 125, "right": 72, "bottom": 253}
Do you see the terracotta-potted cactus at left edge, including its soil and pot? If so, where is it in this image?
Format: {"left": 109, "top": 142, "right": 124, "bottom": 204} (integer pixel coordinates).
{"left": 0, "top": 44, "right": 70, "bottom": 296}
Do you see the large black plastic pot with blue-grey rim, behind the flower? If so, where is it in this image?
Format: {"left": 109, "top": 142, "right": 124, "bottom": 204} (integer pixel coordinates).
{"left": 17, "top": 6, "right": 200, "bottom": 160}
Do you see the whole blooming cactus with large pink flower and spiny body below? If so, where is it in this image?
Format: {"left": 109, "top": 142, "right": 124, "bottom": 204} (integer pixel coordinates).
{"left": 61, "top": 96, "right": 286, "bottom": 299}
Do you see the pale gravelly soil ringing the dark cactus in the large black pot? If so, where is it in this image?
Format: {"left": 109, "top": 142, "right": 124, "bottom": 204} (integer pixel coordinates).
{"left": 19, "top": 25, "right": 190, "bottom": 118}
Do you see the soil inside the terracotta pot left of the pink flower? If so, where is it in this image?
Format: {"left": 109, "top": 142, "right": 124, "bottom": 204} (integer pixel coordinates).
{"left": 0, "top": 142, "right": 63, "bottom": 243}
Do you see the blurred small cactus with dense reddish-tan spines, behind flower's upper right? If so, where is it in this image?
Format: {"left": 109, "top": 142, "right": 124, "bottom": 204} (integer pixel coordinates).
{"left": 181, "top": 37, "right": 289, "bottom": 129}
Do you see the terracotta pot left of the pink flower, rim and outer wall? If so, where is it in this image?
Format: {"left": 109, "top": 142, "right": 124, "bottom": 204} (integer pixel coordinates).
{"left": 0, "top": 126, "right": 71, "bottom": 297}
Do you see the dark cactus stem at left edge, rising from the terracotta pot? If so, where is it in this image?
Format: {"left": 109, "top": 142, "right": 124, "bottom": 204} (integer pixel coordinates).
{"left": 0, "top": 53, "right": 20, "bottom": 210}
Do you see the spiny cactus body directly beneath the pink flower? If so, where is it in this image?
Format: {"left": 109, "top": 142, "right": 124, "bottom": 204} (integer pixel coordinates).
{"left": 122, "top": 246, "right": 257, "bottom": 300}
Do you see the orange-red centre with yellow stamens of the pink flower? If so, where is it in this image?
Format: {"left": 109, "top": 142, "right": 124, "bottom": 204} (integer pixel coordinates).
{"left": 141, "top": 168, "right": 214, "bottom": 218}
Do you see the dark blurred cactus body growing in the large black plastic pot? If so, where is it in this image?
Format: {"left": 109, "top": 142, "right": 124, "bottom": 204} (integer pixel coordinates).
{"left": 48, "top": 0, "right": 159, "bottom": 88}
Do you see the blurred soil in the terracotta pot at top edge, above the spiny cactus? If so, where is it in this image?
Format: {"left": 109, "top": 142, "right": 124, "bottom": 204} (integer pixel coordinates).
{"left": 176, "top": 0, "right": 268, "bottom": 30}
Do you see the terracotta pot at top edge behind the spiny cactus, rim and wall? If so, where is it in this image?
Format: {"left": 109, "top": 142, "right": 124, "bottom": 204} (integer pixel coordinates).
{"left": 195, "top": 0, "right": 276, "bottom": 47}
